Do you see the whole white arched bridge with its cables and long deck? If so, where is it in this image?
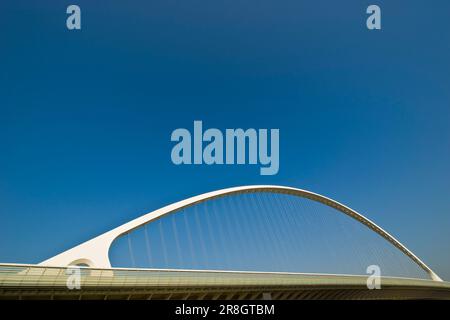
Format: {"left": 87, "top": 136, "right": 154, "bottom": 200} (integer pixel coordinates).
{"left": 0, "top": 185, "right": 450, "bottom": 299}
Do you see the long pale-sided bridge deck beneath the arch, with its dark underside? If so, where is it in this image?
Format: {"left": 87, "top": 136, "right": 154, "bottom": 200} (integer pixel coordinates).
{"left": 0, "top": 265, "right": 450, "bottom": 300}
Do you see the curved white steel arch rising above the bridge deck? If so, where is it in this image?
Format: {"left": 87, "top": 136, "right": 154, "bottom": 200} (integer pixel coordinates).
{"left": 40, "top": 185, "right": 442, "bottom": 281}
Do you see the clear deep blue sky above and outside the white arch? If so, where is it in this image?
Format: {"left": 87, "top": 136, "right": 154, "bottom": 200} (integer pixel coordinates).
{"left": 0, "top": 0, "right": 450, "bottom": 279}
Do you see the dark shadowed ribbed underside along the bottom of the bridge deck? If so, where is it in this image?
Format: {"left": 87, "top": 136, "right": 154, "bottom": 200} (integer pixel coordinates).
{"left": 0, "top": 286, "right": 450, "bottom": 300}
